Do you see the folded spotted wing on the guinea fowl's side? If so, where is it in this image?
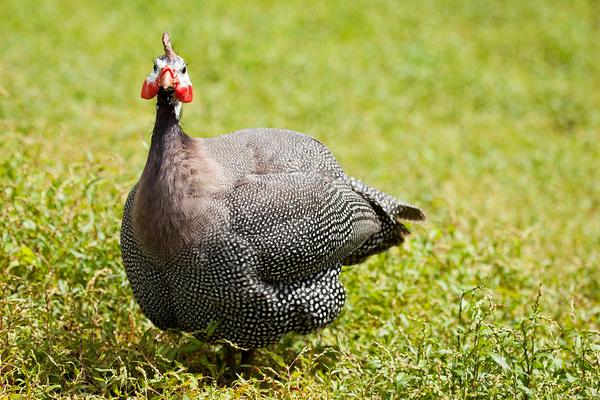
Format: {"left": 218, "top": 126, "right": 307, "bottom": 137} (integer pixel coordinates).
{"left": 227, "top": 172, "right": 380, "bottom": 282}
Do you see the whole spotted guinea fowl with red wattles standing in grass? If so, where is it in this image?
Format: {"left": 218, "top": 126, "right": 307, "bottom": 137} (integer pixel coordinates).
{"left": 121, "top": 33, "right": 425, "bottom": 356}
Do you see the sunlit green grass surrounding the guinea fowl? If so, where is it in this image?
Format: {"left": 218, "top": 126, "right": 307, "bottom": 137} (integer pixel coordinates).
{"left": 0, "top": 0, "right": 600, "bottom": 399}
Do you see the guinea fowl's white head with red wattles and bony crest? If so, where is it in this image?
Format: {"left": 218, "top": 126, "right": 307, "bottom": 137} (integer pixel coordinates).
{"left": 142, "top": 32, "right": 194, "bottom": 103}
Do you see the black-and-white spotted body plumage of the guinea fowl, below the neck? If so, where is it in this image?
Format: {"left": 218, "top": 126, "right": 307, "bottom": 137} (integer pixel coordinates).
{"left": 121, "top": 129, "right": 424, "bottom": 348}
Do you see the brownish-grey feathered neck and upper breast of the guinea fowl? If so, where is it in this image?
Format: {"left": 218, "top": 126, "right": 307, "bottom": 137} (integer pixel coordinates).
{"left": 132, "top": 89, "right": 202, "bottom": 257}
